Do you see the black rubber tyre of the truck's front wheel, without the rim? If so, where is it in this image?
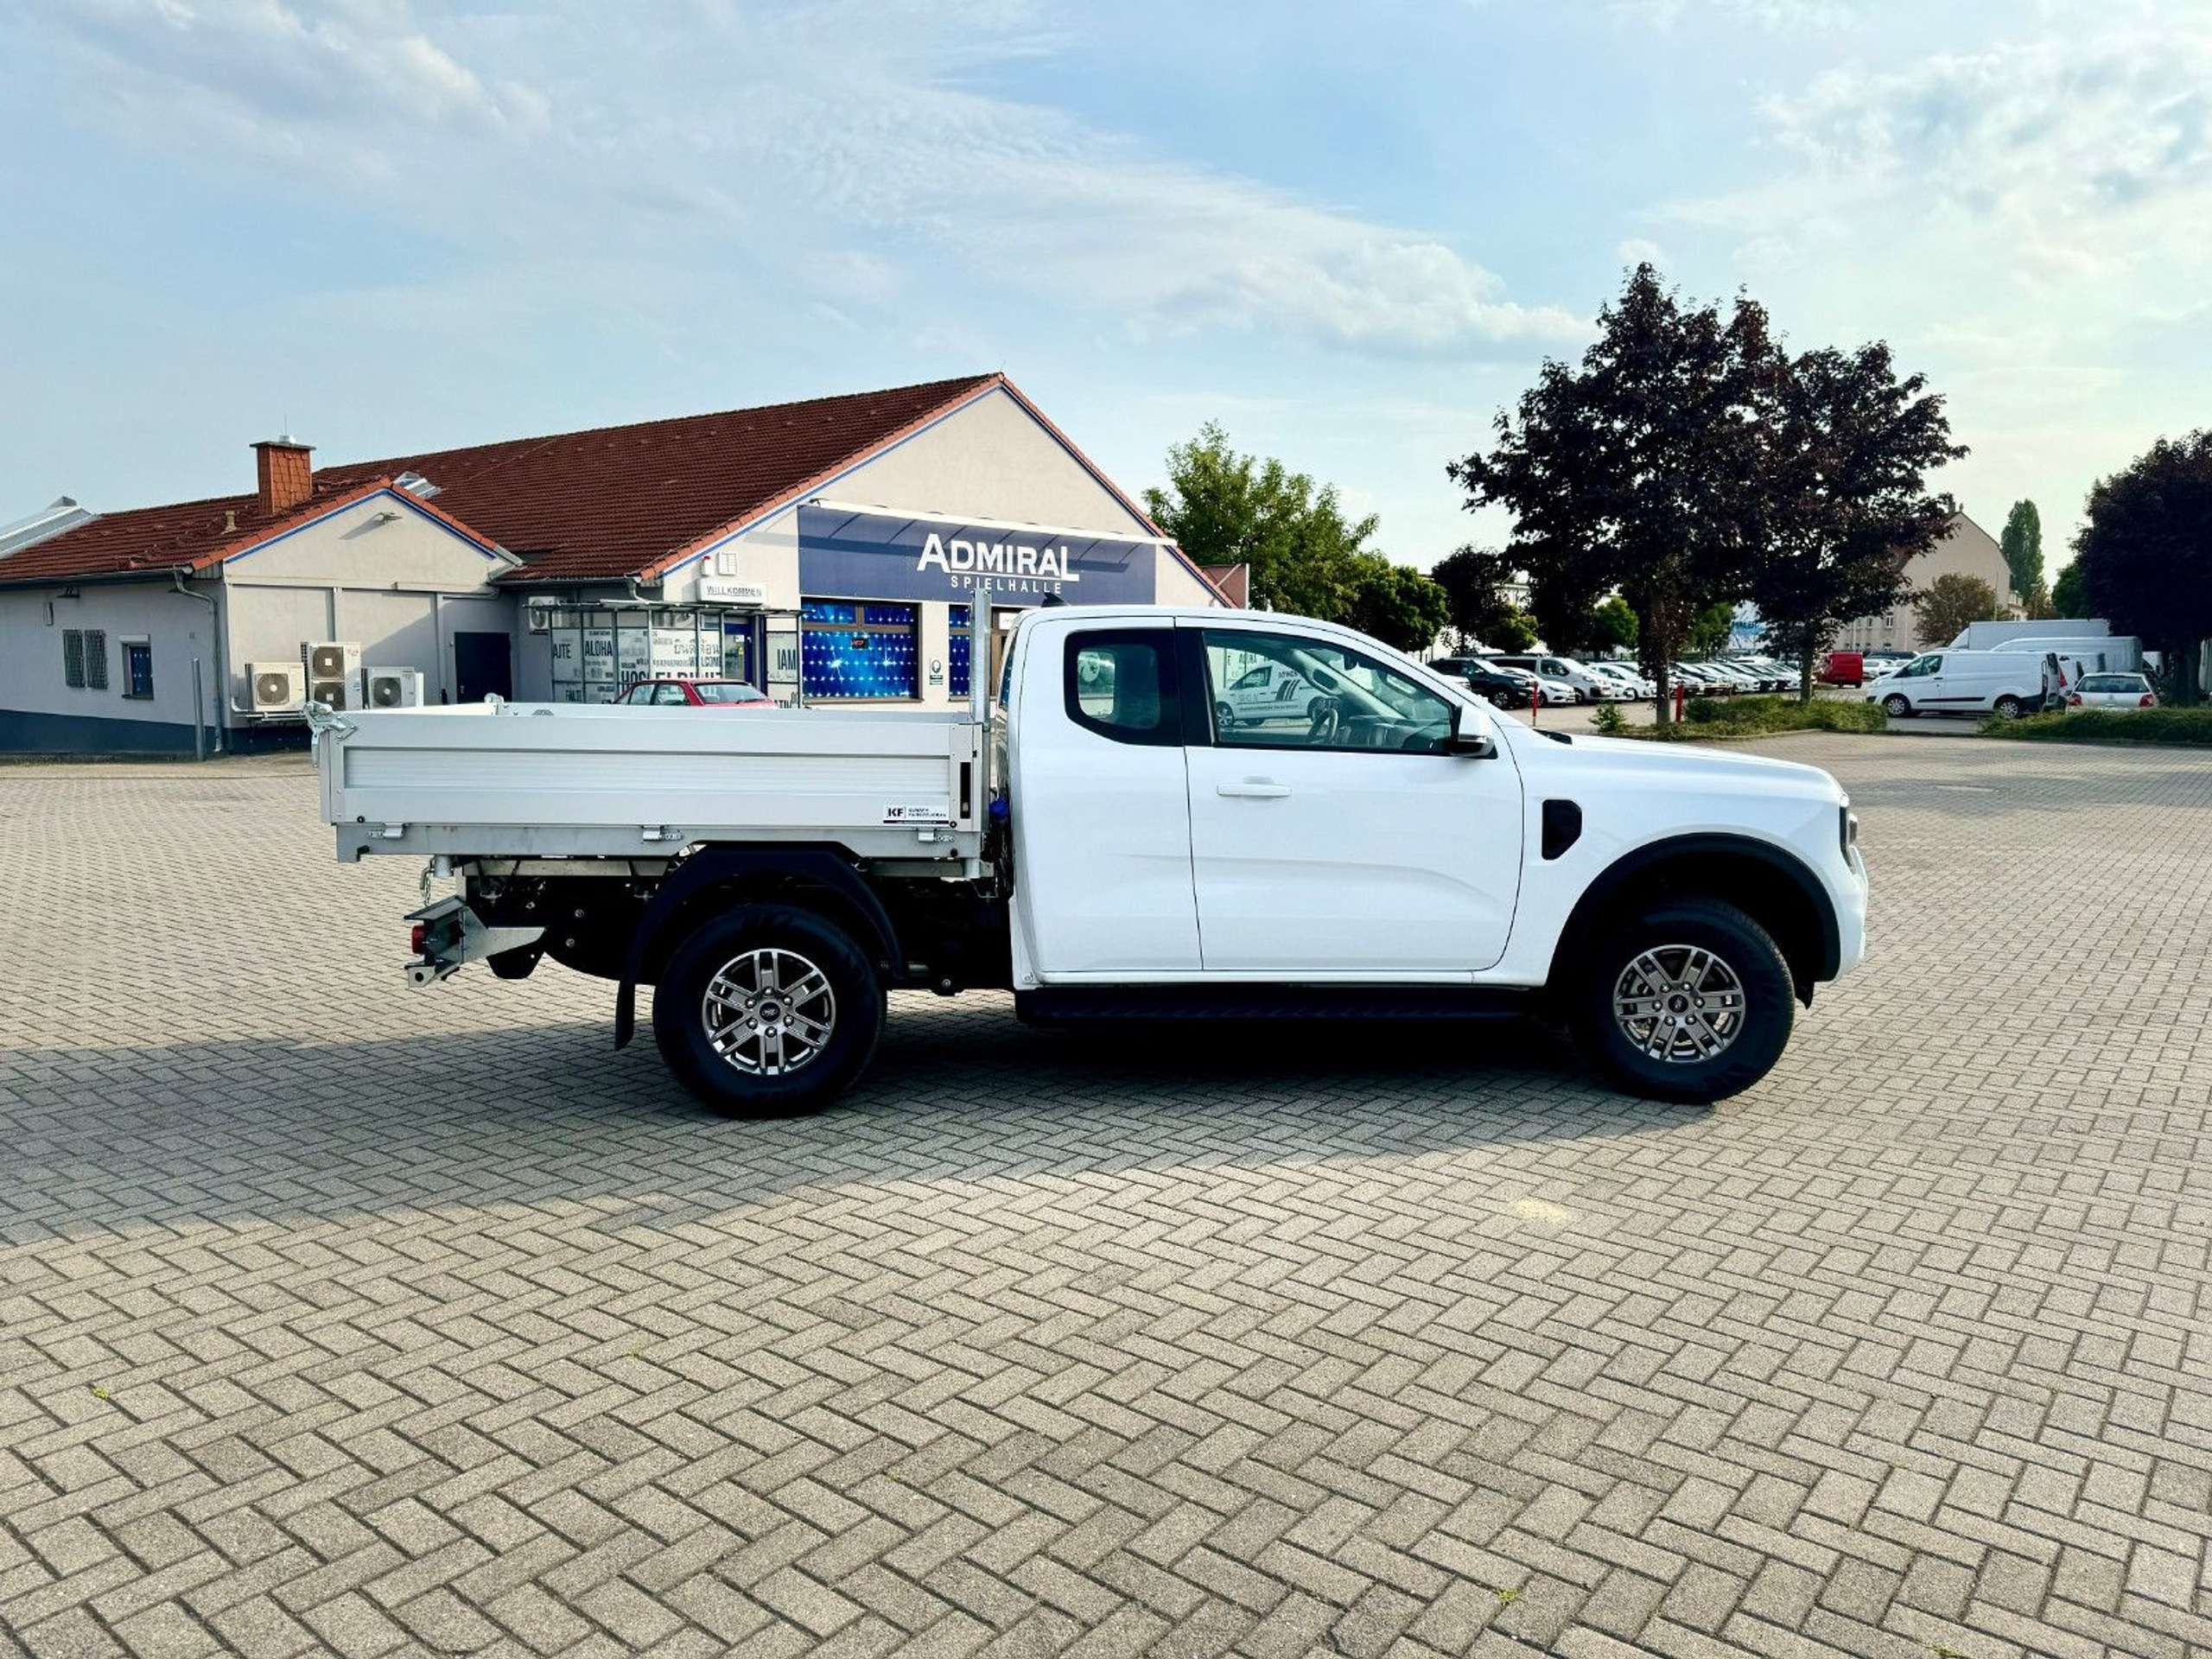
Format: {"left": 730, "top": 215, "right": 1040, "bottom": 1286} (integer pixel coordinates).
{"left": 1568, "top": 898, "right": 1796, "bottom": 1106}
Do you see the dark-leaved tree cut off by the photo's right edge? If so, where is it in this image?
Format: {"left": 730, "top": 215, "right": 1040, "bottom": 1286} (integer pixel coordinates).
{"left": 2059, "top": 429, "right": 2212, "bottom": 706}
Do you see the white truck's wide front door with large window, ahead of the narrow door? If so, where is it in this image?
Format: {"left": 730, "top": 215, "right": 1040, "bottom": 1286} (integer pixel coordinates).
{"left": 1184, "top": 621, "right": 1522, "bottom": 980}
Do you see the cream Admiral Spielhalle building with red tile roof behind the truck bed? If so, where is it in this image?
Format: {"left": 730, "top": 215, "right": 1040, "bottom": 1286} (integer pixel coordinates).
{"left": 0, "top": 374, "right": 1221, "bottom": 752}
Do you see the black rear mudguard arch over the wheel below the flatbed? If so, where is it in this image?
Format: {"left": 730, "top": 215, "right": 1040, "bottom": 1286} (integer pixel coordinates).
{"left": 615, "top": 845, "right": 905, "bottom": 1048}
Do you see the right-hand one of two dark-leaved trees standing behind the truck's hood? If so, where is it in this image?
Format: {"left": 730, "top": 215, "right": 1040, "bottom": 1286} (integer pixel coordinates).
{"left": 1750, "top": 340, "right": 1967, "bottom": 702}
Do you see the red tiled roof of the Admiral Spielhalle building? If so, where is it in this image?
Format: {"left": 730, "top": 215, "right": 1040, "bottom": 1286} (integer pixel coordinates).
{"left": 0, "top": 374, "right": 1004, "bottom": 584}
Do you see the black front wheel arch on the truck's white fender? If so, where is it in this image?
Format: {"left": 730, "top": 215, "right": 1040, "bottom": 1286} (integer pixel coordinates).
{"left": 1551, "top": 834, "right": 1842, "bottom": 1007}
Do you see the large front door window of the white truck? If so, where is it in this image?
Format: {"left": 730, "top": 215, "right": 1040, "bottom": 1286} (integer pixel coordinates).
{"left": 1204, "top": 628, "right": 1451, "bottom": 754}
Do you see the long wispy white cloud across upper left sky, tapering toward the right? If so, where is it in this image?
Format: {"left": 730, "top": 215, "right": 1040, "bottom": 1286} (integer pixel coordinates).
{"left": 21, "top": 0, "right": 1586, "bottom": 354}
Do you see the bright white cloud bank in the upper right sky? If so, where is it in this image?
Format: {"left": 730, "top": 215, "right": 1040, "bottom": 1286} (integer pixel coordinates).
{"left": 1659, "top": 4, "right": 2212, "bottom": 542}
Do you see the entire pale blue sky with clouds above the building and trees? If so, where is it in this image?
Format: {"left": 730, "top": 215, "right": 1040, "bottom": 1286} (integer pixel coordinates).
{"left": 0, "top": 0, "right": 2212, "bottom": 566}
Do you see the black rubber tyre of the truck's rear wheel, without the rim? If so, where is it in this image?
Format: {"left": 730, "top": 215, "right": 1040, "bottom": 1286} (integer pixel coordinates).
{"left": 652, "top": 905, "right": 885, "bottom": 1117}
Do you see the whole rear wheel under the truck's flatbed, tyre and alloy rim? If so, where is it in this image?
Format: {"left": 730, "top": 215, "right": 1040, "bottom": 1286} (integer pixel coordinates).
{"left": 652, "top": 905, "right": 885, "bottom": 1117}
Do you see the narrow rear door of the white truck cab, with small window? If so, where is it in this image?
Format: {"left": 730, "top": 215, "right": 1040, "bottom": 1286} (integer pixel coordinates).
{"left": 1013, "top": 624, "right": 1199, "bottom": 980}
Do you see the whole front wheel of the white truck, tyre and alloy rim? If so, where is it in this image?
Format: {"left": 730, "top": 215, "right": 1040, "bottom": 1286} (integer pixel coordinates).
{"left": 1573, "top": 898, "right": 1794, "bottom": 1103}
